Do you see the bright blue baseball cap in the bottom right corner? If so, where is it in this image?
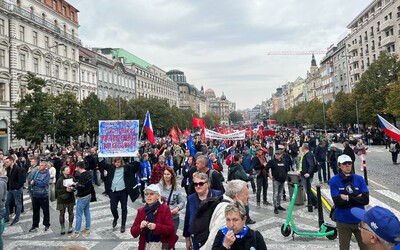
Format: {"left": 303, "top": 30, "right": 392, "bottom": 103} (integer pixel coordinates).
{"left": 350, "top": 206, "right": 400, "bottom": 243}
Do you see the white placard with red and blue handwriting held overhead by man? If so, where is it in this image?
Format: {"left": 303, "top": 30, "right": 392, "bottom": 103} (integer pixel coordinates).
{"left": 99, "top": 120, "right": 139, "bottom": 157}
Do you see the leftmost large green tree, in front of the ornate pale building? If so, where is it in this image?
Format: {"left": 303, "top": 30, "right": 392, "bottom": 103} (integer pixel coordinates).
{"left": 11, "top": 72, "right": 55, "bottom": 144}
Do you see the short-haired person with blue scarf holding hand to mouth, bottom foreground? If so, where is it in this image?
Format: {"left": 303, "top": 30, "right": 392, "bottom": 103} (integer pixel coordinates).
{"left": 212, "top": 200, "right": 267, "bottom": 250}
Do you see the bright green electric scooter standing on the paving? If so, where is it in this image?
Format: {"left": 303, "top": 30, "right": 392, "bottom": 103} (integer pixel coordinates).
{"left": 281, "top": 184, "right": 337, "bottom": 240}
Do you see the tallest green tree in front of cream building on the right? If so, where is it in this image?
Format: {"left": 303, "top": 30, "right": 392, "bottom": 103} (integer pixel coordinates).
{"left": 353, "top": 52, "right": 400, "bottom": 125}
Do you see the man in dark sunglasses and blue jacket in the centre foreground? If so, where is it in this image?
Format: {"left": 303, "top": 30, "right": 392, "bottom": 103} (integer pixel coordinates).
{"left": 183, "top": 171, "right": 222, "bottom": 250}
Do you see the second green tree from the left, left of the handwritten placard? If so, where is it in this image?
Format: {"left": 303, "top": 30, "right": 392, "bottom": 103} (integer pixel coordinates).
{"left": 53, "top": 92, "right": 85, "bottom": 144}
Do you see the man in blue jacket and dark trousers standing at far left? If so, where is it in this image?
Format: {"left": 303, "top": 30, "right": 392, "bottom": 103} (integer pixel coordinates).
{"left": 29, "top": 161, "right": 50, "bottom": 233}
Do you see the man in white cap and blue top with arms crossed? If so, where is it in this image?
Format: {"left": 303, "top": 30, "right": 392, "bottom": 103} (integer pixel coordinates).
{"left": 329, "top": 155, "right": 369, "bottom": 250}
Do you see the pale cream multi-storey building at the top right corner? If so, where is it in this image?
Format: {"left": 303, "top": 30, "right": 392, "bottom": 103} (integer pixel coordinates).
{"left": 346, "top": 0, "right": 400, "bottom": 90}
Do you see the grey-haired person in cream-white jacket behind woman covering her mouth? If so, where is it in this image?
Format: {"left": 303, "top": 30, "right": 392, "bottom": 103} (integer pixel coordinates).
{"left": 202, "top": 180, "right": 255, "bottom": 250}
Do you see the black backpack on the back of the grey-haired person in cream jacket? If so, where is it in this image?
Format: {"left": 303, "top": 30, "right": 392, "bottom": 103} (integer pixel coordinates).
{"left": 193, "top": 195, "right": 229, "bottom": 247}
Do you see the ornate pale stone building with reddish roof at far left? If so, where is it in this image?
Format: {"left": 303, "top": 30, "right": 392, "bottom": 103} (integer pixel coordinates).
{"left": 0, "top": 0, "right": 81, "bottom": 149}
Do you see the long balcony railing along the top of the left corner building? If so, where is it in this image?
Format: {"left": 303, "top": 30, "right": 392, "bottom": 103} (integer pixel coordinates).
{"left": 0, "top": 3, "right": 81, "bottom": 44}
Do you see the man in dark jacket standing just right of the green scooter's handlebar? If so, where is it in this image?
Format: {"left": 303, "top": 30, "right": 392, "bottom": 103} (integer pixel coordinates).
{"left": 300, "top": 143, "right": 317, "bottom": 207}
